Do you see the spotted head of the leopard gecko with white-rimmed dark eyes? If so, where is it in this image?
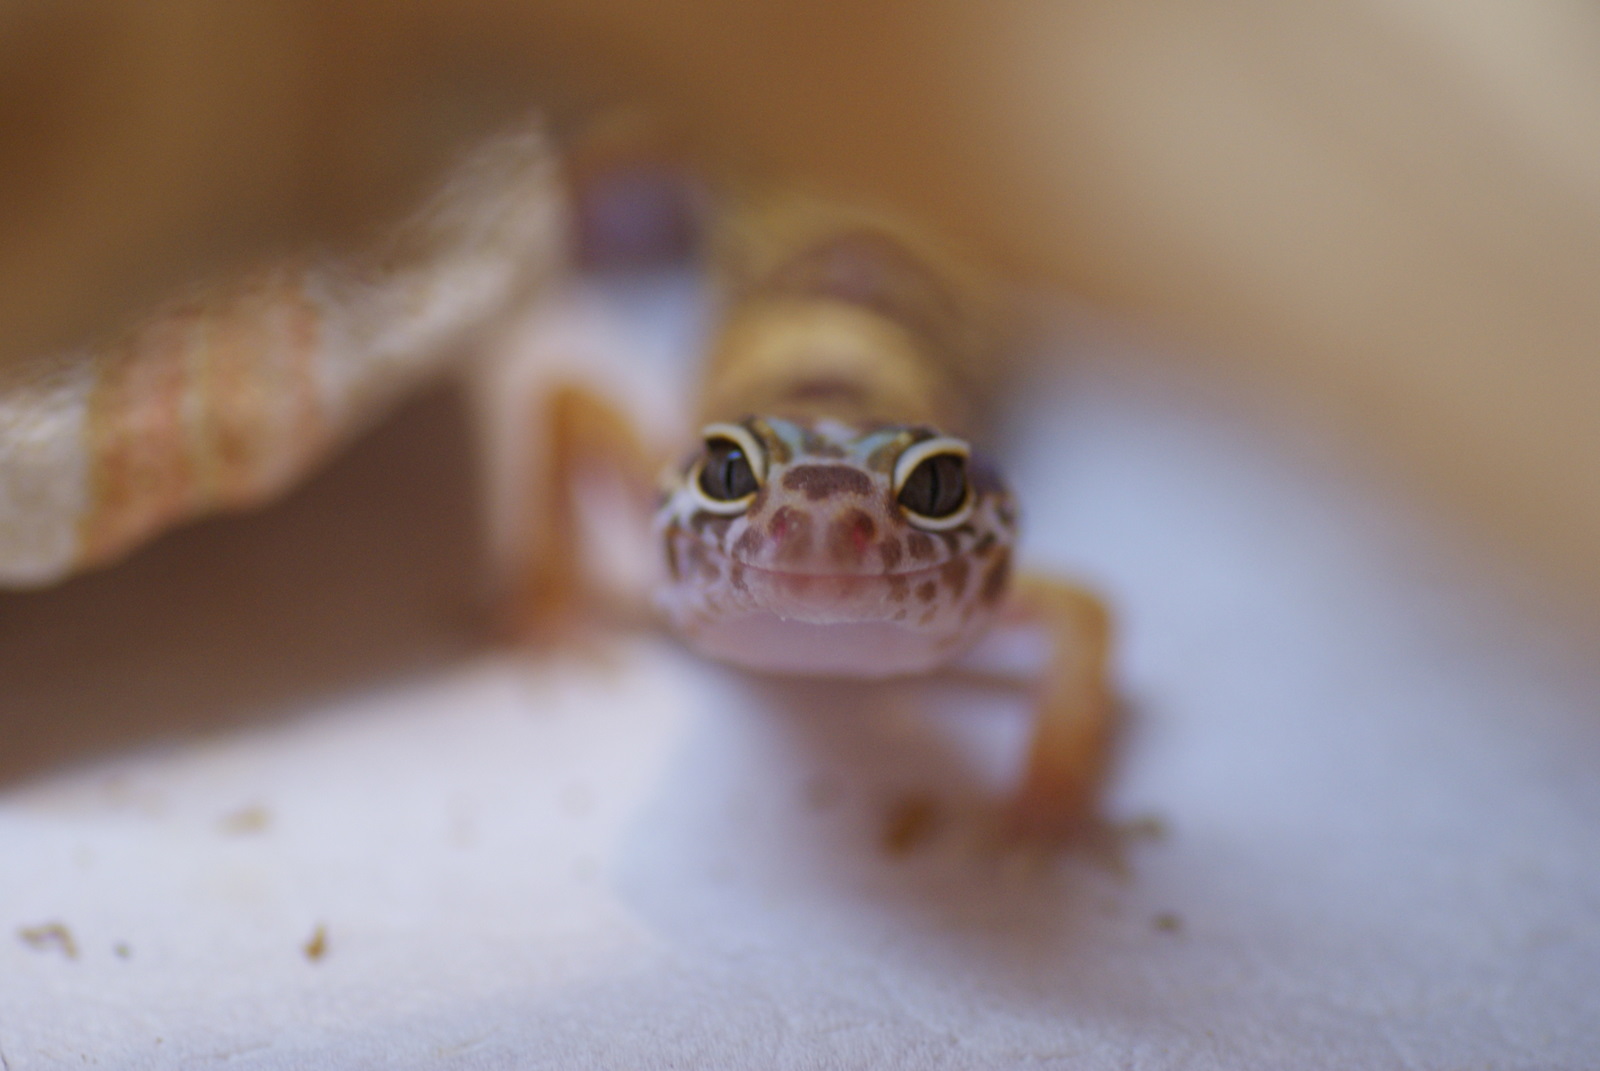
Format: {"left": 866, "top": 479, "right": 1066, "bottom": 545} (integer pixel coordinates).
{"left": 658, "top": 416, "right": 1016, "bottom": 677}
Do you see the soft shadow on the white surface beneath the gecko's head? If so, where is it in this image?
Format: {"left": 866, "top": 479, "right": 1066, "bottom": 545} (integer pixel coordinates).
{"left": 608, "top": 674, "right": 1142, "bottom": 1004}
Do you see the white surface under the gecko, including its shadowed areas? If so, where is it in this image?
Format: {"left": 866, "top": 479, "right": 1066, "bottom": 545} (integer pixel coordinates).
{"left": 0, "top": 288, "right": 1600, "bottom": 1071}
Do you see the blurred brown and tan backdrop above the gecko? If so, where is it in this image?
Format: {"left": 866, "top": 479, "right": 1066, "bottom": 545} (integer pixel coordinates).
{"left": 0, "top": 0, "right": 1600, "bottom": 596}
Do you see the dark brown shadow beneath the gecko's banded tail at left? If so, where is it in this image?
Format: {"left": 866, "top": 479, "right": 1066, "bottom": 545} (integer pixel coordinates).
{"left": 0, "top": 391, "right": 482, "bottom": 784}
